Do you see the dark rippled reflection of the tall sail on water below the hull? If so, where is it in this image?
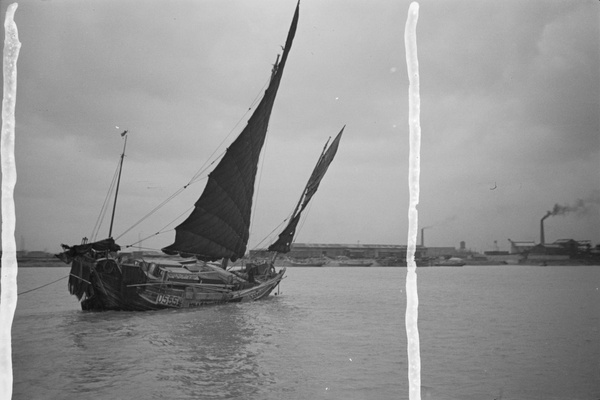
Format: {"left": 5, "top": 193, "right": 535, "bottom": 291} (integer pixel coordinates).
{"left": 149, "top": 305, "right": 269, "bottom": 398}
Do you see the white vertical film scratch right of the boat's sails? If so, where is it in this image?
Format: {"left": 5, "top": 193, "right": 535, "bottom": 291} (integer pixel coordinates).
{"left": 404, "top": 2, "right": 421, "bottom": 400}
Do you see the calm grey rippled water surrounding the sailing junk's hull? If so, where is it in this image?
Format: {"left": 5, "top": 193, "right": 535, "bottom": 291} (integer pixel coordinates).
{"left": 13, "top": 266, "right": 600, "bottom": 400}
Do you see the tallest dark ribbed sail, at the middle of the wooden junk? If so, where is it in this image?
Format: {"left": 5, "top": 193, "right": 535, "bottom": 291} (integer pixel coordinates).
{"left": 162, "top": 3, "right": 300, "bottom": 261}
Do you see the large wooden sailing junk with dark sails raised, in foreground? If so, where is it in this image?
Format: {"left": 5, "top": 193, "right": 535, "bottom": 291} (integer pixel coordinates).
{"left": 57, "top": 4, "right": 344, "bottom": 311}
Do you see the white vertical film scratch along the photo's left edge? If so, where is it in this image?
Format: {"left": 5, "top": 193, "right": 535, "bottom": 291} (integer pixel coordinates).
{"left": 0, "top": 3, "right": 21, "bottom": 399}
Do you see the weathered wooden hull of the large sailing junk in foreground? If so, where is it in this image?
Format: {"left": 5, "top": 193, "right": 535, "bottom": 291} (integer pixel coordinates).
{"left": 71, "top": 257, "right": 285, "bottom": 311}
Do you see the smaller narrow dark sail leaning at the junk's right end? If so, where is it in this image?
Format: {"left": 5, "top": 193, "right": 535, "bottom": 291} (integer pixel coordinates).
{"left": 268, "top": 126, "right": 345, "bottom": 253}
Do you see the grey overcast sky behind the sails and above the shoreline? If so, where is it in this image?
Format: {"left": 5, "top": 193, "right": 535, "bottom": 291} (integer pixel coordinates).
{"left": 2, "top": 0, "right": 600, "bottom": 252}
